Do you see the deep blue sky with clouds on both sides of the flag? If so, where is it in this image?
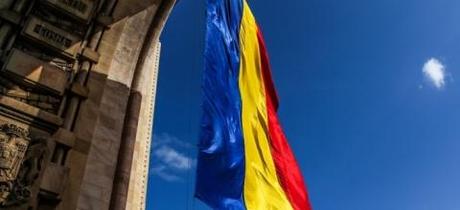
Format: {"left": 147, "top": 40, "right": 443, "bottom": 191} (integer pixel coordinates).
{"left": 148, "top": 0, "right": 460, "bottom": 210}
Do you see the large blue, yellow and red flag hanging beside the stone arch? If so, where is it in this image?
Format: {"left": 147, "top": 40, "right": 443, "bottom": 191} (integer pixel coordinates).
{"left": 195, "top": 0, "right": 311, "bottom": 210}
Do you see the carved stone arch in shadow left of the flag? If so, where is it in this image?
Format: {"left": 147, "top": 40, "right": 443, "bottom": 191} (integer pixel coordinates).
{"left": 0, "top": 0, "right": 175, "bottom": 210}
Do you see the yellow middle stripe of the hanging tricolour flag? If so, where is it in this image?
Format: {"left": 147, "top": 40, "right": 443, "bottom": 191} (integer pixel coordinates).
{"left": 239, "top": 1, "right": 292, "bottom": 210}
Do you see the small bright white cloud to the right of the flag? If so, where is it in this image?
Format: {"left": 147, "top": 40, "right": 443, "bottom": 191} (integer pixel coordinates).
{"left": 423, "top": 58, "right": 446, "bottom": 89}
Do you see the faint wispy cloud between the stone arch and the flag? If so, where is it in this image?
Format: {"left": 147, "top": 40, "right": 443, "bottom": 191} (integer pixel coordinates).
{"left": 150, "top": 133, "right": 196, "bottom": 182}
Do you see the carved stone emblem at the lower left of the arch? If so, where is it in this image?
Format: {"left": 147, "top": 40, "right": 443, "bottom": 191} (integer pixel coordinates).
{"left": 0, "top": 124, "right": 46, "bottom": 208}
